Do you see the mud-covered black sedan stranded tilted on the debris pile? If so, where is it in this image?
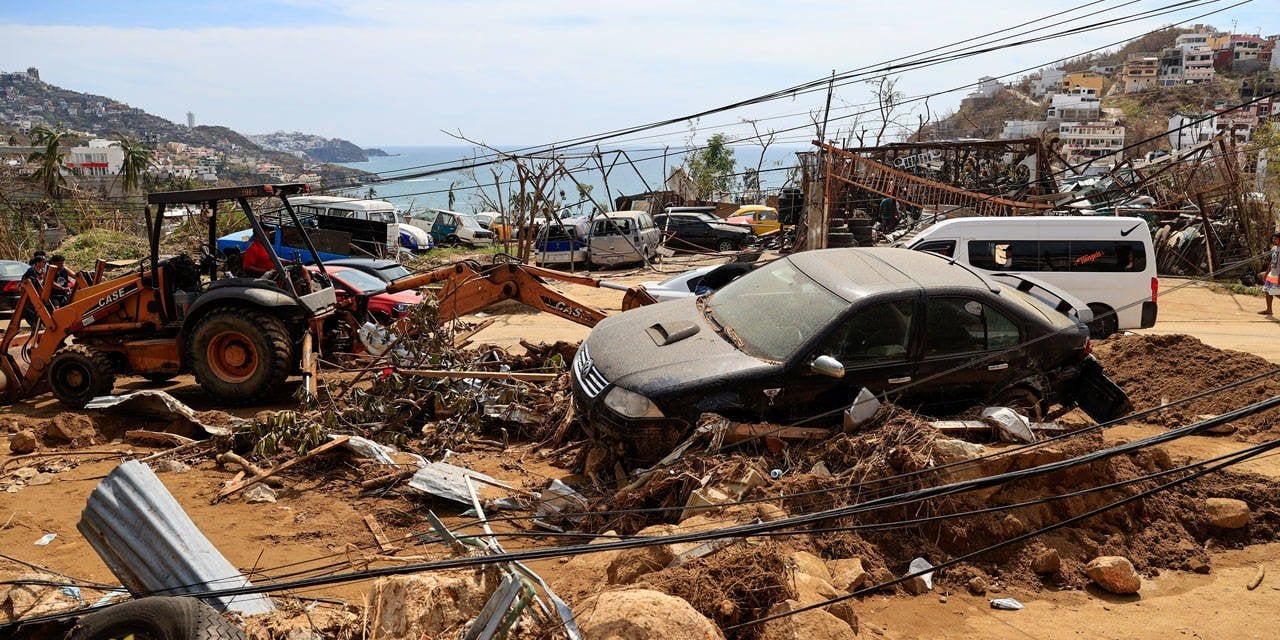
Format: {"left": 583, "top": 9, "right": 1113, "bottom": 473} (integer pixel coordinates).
{"left": 572, "top": 248, "right": 1129, "bottom": 462}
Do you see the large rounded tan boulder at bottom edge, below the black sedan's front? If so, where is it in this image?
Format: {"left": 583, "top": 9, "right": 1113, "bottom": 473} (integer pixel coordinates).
{"left": 573, "top": 589, "right": 724, "bottom": 640}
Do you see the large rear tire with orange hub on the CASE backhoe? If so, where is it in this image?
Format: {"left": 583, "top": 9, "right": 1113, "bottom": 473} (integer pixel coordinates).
{"left": 187, "top": 307, "right": 293, "bottom": 404}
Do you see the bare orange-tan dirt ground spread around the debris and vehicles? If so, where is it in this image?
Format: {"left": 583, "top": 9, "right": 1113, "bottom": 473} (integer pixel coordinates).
{"left": 0, "top": 259, "right": 1280, "bottom": 640}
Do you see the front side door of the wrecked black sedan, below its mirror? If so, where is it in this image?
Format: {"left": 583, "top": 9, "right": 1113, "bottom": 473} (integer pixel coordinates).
{"left": 767, "top": 296, "right": 918, "bottom": 420}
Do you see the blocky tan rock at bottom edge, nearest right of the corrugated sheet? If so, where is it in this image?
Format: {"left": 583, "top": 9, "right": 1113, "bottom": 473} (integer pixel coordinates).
{"left": 369, "top": 572, "right": 489, "bottom": 640}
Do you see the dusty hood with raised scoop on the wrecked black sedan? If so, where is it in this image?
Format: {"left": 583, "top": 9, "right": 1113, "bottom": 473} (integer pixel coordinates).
{"left": 585, "top": 297, "right": 781, "bottom": 399}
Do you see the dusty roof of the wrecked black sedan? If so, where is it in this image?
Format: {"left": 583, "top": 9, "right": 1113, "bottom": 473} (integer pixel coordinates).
{"left": 790, "top": 247, "right": 1000, "bottom": 301}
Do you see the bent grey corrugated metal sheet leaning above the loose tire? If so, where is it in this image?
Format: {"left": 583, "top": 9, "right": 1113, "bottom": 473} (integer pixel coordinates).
{"left": 77, "top": 461, "right": 275, "bottom": 616}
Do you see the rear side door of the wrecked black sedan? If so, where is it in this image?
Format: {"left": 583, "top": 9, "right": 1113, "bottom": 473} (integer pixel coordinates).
{"left": 904, "top": 294, "right": 1027, "bottom": 413}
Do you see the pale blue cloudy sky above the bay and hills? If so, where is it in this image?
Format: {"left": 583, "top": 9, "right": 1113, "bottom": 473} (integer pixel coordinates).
{"left": 0, "top": 0, "right": 1280, "bottom": 146}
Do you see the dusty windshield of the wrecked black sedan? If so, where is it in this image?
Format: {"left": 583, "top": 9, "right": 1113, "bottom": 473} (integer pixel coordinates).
{"left": 705, "top": 260, "right": 849, "bottom": 361}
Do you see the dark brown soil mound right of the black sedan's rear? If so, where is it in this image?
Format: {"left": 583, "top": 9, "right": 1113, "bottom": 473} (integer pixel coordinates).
{"left": 1093, "top": 334, "right": 1280, "bottom": 436}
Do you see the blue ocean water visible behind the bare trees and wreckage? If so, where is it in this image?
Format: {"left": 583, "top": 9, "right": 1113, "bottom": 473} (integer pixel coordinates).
{"left": 343, "top": 146, "right": 805, "bottom": 212}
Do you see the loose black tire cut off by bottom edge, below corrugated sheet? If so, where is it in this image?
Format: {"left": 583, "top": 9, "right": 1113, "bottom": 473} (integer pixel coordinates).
{"left": 69, "top": 596, "right": 244, "bottom": 640}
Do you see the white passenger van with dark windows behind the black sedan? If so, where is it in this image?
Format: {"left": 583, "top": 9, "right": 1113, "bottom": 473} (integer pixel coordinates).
{"left": 908, "top": 216, "right": 1160, "bottom": 338}
